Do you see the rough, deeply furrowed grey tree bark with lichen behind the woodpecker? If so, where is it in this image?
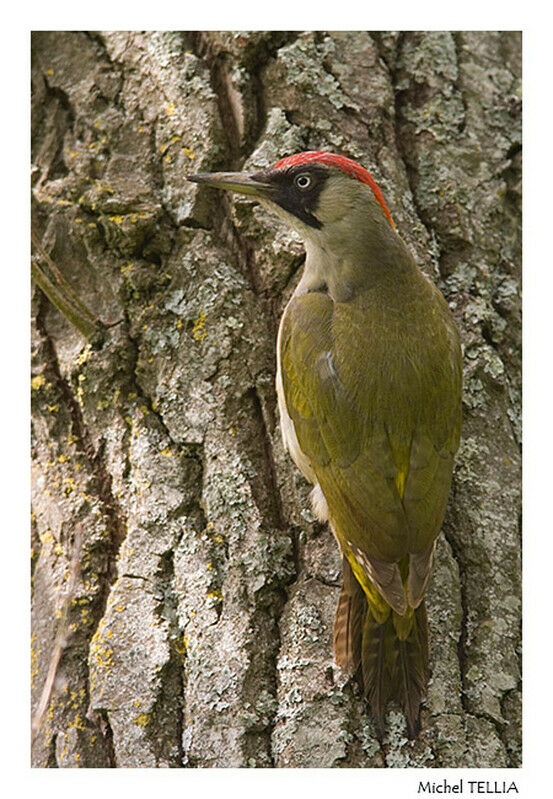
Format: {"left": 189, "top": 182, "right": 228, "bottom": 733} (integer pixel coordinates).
{"left": 31, "top": 32, "right": 521, "bottom": 767}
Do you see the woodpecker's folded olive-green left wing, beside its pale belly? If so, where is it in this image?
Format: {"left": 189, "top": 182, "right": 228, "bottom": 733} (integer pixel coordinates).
{"left": 280, "top": 292, "right": 407, "bottom": 613}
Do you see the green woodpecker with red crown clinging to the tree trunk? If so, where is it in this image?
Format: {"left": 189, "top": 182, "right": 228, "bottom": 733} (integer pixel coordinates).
{"left": 189, "top": 152, "right": 462, "bottom": 737}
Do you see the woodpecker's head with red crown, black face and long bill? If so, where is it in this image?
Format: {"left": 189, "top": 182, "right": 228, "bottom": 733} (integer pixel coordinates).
{"left": 188, "top": 152, "right": 395, "bottom": 260}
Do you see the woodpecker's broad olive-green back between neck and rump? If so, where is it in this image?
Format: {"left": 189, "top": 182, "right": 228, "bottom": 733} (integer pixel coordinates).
{"left": 281, "top": 270, "right": 461, "bottom": 561}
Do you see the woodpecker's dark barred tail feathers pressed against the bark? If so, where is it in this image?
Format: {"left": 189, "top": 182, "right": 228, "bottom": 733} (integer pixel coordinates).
{"left": 334, "top": 566, "right": 429, "bottom": 738}
